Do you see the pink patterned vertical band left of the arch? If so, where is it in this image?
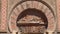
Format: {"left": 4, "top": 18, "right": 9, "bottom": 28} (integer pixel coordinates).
{"left": 0, "top": 0, "right": 7, "bottom": 32}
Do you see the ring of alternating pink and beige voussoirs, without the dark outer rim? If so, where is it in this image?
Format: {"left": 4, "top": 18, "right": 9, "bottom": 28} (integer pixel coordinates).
{"left": 9, "top": 1, "right": 55, "bottom": 31}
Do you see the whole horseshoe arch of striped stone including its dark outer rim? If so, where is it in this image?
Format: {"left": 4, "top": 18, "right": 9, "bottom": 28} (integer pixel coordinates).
{"left": 9, "top": 0, "right": 56, "bottom": 32}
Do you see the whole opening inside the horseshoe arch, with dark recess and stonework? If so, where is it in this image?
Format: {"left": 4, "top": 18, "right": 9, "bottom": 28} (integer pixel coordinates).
{"left": 16, "top": 8, "right": 48, "bottom": 34}
